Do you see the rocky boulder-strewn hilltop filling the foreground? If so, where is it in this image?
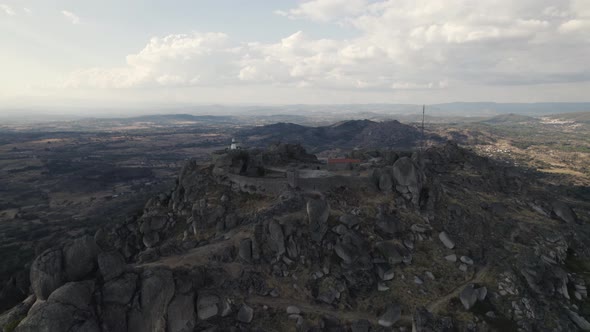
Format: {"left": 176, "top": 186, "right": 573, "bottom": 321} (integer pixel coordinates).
{"left": 0, "top": 143, "right": 590, "bottom": 332}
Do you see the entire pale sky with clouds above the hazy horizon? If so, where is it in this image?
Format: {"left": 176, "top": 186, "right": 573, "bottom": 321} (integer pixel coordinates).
{"left": 0, "top": 0, "right": 590, "bottom": 109}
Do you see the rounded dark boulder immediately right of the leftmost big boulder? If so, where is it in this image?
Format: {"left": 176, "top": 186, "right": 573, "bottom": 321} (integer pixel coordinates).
{"left": 63, "top": 236, "right": 98, "bottom": 281}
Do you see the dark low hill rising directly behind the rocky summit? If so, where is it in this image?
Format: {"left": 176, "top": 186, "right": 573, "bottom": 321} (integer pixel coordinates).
{"left": 236, "top": 120, "right": 440, "bottom": 151}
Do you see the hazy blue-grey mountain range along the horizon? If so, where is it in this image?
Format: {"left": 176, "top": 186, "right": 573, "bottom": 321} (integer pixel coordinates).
{"left": 0, "top": 102, "right": 590, "bottom": 123}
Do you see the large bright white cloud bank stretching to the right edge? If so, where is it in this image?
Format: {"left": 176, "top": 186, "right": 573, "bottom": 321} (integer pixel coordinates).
{"left": 64, "top": 0, "right": 590, "bottom": 92}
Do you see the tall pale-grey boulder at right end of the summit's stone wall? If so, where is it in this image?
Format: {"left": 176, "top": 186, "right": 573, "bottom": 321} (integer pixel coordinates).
{"left": 393, "top": 157, "right": 422, "bottom": 205}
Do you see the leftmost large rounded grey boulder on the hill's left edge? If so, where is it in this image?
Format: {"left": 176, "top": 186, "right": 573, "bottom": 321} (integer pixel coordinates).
{"left": 30, "top": 248, "right": 66, "bottom": 300}
